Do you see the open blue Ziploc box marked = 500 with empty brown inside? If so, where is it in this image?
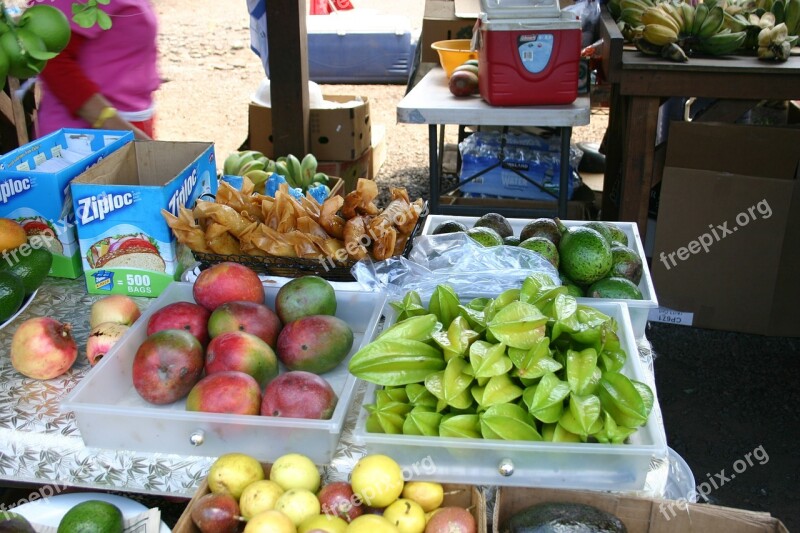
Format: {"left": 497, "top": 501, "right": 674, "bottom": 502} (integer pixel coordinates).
{"left": 70, "top": 141, "right": 217, "bottom": 297}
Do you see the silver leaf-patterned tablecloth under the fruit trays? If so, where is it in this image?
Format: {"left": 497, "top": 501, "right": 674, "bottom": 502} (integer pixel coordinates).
{"left": 0, "top": 278, "right": 671, "bottom": 497}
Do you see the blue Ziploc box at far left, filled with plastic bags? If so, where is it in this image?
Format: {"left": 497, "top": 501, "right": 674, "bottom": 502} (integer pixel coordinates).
{"left": 0, "top": 128, "right": 133, "bottom": 278}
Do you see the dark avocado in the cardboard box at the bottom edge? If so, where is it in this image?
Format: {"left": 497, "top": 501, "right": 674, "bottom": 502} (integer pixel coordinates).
{"left": 510, "top": 502, "right": 628, "bottom": 533}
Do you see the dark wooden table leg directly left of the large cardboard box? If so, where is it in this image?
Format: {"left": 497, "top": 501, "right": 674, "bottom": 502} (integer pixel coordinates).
{"left": 612, "top": 96, "right": 660, "bottom": 239}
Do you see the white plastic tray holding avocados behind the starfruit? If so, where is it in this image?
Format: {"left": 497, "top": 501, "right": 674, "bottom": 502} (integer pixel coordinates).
{"left": 421, "top": 215, "right": 658, "bottom": 339}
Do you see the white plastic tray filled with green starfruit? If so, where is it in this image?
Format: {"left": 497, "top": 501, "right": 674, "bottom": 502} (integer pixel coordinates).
{"left": 353, "top": 300, "right": 668, "bottom": 491}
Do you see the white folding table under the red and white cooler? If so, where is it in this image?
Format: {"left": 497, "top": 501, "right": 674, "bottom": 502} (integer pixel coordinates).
{"left": 397, "top": 67, "right": 589, "bottom": 218}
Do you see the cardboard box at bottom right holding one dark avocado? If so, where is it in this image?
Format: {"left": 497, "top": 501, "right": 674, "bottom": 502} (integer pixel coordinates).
{"left": 492, "top": 487, "right": 788, "bottom": 533}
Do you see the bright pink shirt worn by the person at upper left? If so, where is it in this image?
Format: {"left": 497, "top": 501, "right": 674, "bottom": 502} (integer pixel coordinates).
{"left": 37, "top": 0, "right": 161, "bottom": 136}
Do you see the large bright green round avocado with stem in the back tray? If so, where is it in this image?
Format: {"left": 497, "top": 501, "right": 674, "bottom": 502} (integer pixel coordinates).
{"left": 556, "top": 219, "right": 611, "bottom": 285}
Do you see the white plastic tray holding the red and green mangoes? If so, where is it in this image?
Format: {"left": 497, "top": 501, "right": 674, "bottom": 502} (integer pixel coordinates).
{"left": 61, "top": 282, "right": 386, "bottom": 464}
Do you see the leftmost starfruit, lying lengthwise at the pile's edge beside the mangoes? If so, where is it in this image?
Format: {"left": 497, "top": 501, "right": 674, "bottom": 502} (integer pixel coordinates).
{"left": 348, "top": 339, "right": 445, "bottom": 386}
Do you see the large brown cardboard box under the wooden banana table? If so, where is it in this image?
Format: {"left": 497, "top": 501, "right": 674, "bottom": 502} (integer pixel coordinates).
{"left": 651, "top": 122, "right": 800, "bottom": 337}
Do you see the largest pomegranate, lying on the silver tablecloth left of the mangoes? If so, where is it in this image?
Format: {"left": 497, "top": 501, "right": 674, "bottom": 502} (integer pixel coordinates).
{"left": 11, "top": 317, "right": 78, "bottom": 379}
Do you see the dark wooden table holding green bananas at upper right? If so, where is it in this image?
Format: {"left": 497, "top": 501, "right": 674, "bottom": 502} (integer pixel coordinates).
{"left": 600, "top": 10, "right": 800, "bottom": 239}
